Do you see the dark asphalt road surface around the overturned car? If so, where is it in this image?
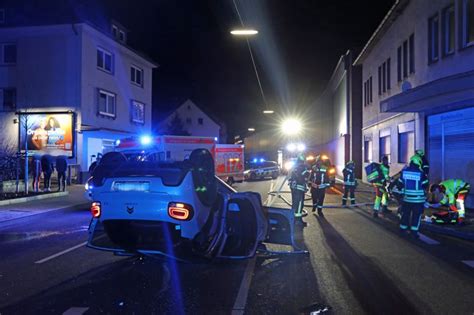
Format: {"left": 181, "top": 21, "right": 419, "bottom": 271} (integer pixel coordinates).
{"left": 0, "top": 178, "right": 474, "bottom": 315}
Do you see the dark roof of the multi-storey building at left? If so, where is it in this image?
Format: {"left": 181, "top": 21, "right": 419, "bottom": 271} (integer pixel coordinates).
{"left": 0, "top": 0, "right": 158, "bottom": 67}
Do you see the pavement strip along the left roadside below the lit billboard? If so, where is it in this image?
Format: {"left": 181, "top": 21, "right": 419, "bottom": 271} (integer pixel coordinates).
{"left": 0, "top": 185, "right": 88, "bottom": 223}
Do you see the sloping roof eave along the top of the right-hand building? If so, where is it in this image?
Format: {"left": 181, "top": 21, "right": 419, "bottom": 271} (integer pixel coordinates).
{"left": 354, "top": 0, "right": 410, "bottom": 65}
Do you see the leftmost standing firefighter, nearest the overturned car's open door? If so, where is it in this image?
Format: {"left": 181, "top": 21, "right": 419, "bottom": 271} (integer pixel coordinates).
{"left": 288, "top": 154, "right": 309, "bottom": 224}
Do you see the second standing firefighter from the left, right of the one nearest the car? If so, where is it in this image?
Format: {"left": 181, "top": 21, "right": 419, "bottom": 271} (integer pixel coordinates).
{"left": 309, "top": 156, "right": 330, "bottom": 216}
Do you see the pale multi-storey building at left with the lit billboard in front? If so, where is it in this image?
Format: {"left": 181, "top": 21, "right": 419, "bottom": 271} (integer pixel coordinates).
{"left": 0, "top": 22, "right": 156, "bottom": 180}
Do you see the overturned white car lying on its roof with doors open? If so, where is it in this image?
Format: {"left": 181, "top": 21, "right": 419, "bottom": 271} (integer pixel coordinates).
{"left": 88, "top": 149, "right": 300, "bottom": 259}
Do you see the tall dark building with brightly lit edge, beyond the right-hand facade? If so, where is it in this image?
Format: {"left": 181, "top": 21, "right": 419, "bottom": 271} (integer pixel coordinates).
{"left": 308, "top": 51, "right": 362, "bottom": 178}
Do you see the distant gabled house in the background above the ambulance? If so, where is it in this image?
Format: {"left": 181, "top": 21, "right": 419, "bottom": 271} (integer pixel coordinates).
{"left": 159, "top": 99, "right": 222, "bottom": 143}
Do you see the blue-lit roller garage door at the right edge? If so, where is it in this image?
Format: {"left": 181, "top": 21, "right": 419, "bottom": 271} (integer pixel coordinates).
{"left": 428, "top": 107, "right": 474, "bottom": 208}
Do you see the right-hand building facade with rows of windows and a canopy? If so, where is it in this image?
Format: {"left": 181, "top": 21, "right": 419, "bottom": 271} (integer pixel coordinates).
{"left": 355, "top": 0, "right": 474, "bottom": 207}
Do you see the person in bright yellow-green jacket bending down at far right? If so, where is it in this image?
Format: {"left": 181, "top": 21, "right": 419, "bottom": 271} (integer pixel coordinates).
{"left": 430, "top": 179, "right": 471, "bottom": 224}
